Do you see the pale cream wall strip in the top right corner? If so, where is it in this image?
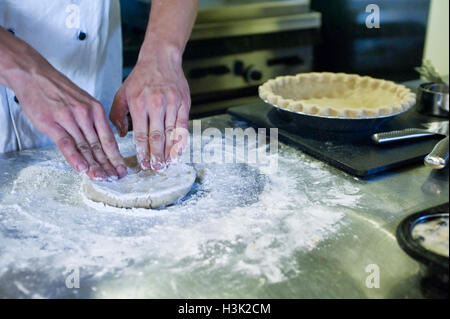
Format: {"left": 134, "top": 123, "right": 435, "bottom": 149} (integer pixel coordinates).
{"left": 424, "top": 0, "right": 449, "bottom": 75}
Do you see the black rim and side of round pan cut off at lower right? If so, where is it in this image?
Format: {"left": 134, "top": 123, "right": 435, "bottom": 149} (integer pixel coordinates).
{"left": 396, "top": 212, "right": 449, "bottom": 290}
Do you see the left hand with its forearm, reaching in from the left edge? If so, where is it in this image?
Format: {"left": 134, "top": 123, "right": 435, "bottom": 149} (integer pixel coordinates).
{"left": 0, "top": 28, "right": 127, "bottom": 179}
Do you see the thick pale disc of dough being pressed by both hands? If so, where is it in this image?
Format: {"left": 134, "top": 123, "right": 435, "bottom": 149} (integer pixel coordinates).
{"left": 81, "top": 156, "right": 197, "bottom": 208}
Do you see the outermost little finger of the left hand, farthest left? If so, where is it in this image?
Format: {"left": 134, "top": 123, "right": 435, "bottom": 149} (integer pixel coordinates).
{"left": 46, "top": 123, "right": 89, "bottom": 173}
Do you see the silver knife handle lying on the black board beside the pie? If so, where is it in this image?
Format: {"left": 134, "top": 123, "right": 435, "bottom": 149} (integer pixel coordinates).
{"left": 372, "top": 121, "right": 449, "bottom": 144}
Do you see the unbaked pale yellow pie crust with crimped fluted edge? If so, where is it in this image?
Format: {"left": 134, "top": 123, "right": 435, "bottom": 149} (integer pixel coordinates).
{"left": 259, "top": 72, "right": 416, "bottom": 119}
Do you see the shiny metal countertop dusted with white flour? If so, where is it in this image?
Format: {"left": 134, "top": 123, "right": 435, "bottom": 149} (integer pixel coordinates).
{"left": 0, "top": 115, "right": 448, "bottom": 298}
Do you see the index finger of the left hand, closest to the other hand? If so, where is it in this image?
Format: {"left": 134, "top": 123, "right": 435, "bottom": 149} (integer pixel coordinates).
{"left": 94, "top": 105, "right": 127, "bottom": 178}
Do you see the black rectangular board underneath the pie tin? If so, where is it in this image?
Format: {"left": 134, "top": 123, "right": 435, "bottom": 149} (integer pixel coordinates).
{"left": 228, "top": 103, "right": 443, "bottom": 177}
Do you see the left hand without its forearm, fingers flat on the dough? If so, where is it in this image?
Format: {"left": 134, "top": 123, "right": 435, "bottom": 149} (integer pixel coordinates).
{"left": 19, "top": 70, "right": 127, "bottom": 180}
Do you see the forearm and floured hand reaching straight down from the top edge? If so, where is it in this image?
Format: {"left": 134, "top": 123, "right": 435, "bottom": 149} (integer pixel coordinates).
{"left": 110, "top": 0, "right": 198, "bottom": 170}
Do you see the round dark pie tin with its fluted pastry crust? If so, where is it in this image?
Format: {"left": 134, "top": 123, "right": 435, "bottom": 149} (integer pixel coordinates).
{"left": 258, "top": 72, "right": 416, "bottom": 132}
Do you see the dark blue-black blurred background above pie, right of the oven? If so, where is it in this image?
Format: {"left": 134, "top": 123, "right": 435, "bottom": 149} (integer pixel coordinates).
{"left": 311, "top": 0, "right": 428, "bottom": 82}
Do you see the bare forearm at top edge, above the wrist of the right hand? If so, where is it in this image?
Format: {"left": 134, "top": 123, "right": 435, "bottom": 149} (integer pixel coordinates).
{"left": 139, "top": 0, "right": 198, "bottom": 63}
